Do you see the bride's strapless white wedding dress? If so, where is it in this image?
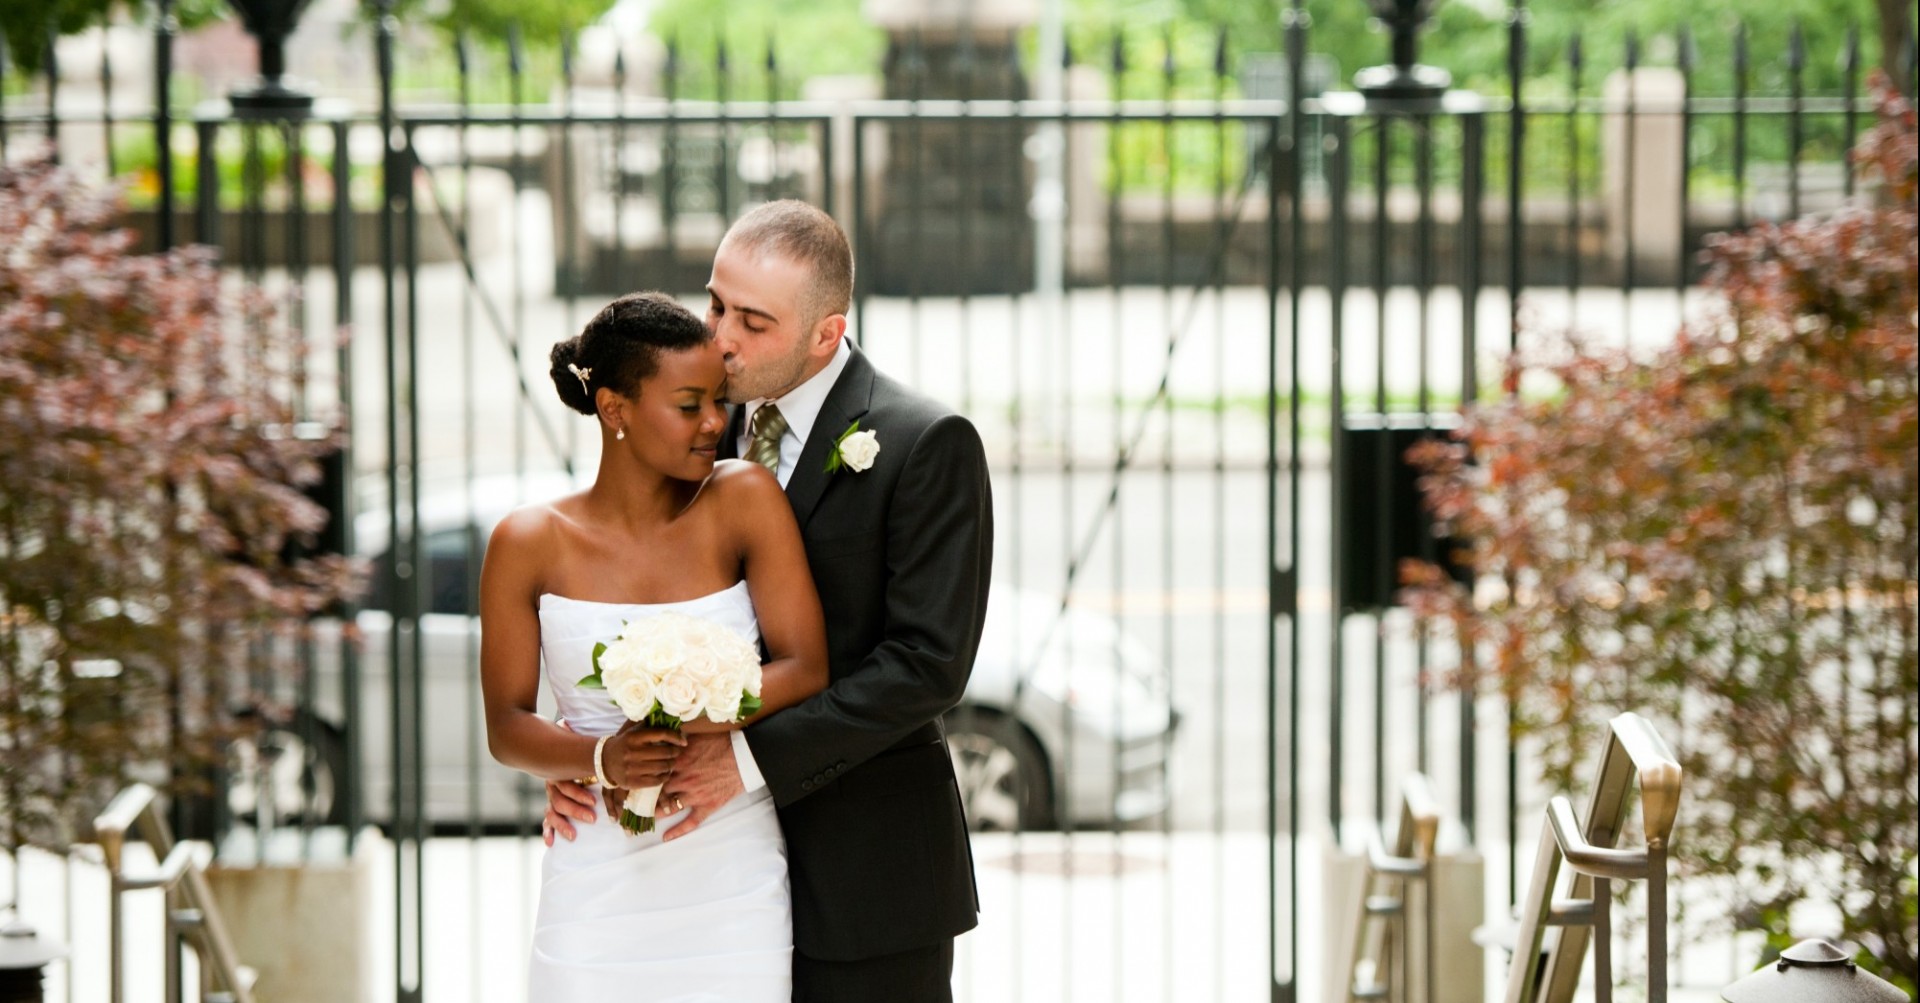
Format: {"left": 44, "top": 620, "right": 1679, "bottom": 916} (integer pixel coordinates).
{"left": 528, "top": 582, "right": 793, "bottom": 1003}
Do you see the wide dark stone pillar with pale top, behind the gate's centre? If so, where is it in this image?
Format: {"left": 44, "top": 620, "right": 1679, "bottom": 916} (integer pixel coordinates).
{"left": 854, "top": 0, "right": 1037, "bottom": 296}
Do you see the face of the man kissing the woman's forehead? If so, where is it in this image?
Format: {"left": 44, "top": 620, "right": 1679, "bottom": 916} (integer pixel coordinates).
{"left": 707, "top": 242, "right": 818, "bottom": 404}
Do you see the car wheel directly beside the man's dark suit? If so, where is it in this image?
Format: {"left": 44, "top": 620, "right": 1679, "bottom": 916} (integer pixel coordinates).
{"left": 947, "top": 711, "right": 1054, "bottom": 832}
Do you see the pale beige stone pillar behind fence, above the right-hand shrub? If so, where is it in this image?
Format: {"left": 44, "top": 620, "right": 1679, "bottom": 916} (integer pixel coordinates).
{"left": 1601, "top": 67, "right": 1686, "bottom": 286}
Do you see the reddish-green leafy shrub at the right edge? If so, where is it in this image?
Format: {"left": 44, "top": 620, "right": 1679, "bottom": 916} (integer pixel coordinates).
{"left": 1409, "top": 80, "right": 1920, "bottom": 986}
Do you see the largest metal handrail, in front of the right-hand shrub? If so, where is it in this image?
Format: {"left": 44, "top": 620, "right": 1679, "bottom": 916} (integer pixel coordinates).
{"left": 1505, "top": 713, "right": 1682, "bottom": 1003}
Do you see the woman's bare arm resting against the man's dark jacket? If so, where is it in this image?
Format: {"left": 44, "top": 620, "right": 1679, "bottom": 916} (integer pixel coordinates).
{"left": 682, "top": 463, "right": 828, "bottom": 734}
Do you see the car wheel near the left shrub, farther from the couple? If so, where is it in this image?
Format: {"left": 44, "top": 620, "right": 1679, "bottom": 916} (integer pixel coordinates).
{"left": 227, "top": 711, "right": 348, "bottom": 826}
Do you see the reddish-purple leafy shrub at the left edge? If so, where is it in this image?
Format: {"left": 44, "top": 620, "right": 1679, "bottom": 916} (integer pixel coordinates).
{"left": 0, "top": 155, "right": 351, "bottom": 845}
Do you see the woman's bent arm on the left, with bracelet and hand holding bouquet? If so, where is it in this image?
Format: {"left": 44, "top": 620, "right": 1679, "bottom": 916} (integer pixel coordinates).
{"left": 480, "top": 509, "right": 684, "bottom": 786}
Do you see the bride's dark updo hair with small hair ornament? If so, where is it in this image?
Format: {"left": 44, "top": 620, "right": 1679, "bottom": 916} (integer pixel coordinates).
{"left": 547, "top": 292, "right": 712, "bottom": 415}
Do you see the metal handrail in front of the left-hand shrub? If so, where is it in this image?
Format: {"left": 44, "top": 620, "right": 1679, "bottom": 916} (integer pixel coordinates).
{"left": 94, "top": 784, "right": 253, "bottom": 1003}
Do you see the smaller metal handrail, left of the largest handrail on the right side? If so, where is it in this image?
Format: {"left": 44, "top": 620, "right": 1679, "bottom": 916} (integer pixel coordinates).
{"left": 1348, "top": 772, "right": 1440, "bottom": 1003}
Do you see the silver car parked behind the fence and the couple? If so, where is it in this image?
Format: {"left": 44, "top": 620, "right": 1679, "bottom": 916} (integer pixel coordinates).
{"left": 228, "top": 475, "right": 1177, "bottom": 830}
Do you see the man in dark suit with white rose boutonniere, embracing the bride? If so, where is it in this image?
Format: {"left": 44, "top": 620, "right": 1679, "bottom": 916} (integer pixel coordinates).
{"left": 547, "top": 202, "right": 993, "bottom": 1003}
